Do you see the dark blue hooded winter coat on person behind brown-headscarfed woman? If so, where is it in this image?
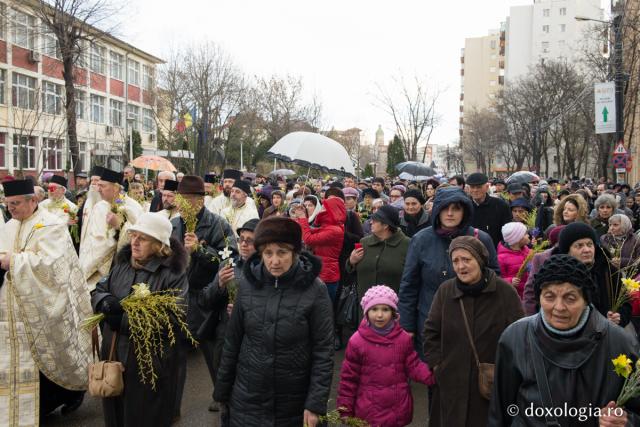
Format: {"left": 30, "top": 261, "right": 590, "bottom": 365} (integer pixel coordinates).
{"left": 398, "top": 187, "right": 500, "bottom": 358}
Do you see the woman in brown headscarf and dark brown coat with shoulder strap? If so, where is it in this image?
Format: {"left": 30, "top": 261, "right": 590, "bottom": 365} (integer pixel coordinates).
{"left": 424, "top": 236, "right": 524, "bottom": 427}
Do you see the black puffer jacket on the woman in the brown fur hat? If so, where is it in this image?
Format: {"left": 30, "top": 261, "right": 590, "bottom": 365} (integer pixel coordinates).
{"left": 214, "top": 252, "right": 333, "bottom": 427}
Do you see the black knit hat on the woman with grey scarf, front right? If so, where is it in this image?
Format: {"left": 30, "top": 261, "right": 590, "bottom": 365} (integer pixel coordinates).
{"left": 533, "top": 256, "right": 595, "bottom": 303}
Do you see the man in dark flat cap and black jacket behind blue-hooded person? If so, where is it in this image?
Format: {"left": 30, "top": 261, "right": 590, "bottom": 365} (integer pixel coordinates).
{"left": 467, "top": 172, "right": 511, "bottom": 247}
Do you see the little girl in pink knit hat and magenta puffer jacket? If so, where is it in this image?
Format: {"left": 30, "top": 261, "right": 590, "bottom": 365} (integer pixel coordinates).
{"left": 337, "top": 286, "right": 435, "bottom": 427}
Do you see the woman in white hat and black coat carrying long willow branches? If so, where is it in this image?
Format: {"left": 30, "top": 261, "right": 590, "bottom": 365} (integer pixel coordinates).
{"left": 91, "top": 213, "right": 187, "bottom": 427}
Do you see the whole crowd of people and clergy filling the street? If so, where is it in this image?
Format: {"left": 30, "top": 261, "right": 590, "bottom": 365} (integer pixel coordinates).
{"left": 0, "top": 166, "right": 640, "bottom": 427}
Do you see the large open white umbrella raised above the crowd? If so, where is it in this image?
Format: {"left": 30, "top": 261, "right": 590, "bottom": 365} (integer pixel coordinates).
{"left": 267, "top": 132, "right": 355, "bottom": 175}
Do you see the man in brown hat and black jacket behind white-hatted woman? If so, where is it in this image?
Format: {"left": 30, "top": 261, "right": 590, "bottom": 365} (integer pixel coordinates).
{"left": 171, "top": 175, "right": 238, "bottom": 415}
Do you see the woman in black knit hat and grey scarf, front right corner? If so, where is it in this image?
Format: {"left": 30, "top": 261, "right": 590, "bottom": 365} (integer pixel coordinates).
{"left": 488, "top": 256, "right": 640, "bottom": 427}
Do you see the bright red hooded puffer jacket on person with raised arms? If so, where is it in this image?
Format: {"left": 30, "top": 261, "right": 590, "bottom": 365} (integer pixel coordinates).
{"left": 297, "top": 197, "right": 347, "bottom": 283}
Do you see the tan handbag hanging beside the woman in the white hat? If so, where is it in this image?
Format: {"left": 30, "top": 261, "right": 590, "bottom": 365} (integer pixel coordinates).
{"left": 89, "top": 328, "right": 124, "bottom": 397}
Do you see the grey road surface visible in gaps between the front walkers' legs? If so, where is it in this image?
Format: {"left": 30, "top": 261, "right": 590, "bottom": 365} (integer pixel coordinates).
{"left": 43, "top": 351, "right": 427, "bottom": 427}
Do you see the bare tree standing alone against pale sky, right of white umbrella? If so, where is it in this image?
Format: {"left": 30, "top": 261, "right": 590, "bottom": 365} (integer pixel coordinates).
{"left": 376, "top": 76, "right": 442, "bottom": 162}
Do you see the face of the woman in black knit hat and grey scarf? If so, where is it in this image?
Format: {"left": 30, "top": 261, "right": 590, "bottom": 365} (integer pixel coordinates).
{"left": 540, "top": 282, "right": 587, "bottom": 330}
